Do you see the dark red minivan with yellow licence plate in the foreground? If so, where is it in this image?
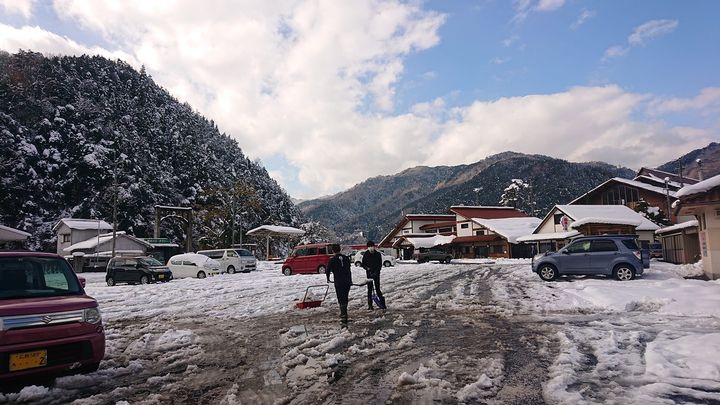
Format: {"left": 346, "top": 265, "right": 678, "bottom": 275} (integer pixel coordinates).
{"left": 0, "top": 252, "right": 105, "bottom": 384}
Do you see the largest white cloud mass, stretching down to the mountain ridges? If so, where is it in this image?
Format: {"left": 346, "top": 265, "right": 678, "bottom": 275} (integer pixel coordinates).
{"left": 0, "top": 0, "right": 717, "bottom": 197}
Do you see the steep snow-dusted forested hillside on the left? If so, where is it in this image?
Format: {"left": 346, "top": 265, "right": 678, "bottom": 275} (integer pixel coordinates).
{"left": 0, "top": 52, "right": 300, "bottom": 250}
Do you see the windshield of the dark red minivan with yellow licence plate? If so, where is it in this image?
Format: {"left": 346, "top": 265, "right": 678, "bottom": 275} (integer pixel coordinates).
{"left": 0, "top": 257, "right": 82, "bottom": 299}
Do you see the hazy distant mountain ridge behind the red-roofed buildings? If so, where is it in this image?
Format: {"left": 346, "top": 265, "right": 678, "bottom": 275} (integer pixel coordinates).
{"left": 299, "top": 152, "right": 634, "bottom": 239}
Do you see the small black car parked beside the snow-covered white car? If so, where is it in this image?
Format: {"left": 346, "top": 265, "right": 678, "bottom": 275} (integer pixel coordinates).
{"left": 105, "top": 256, "right": 173, "bottom": 286}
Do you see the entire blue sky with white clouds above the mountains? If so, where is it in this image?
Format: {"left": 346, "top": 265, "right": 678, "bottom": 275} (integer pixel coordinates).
{"left": 0, "top": 0, "right": 720, "bottom": 199}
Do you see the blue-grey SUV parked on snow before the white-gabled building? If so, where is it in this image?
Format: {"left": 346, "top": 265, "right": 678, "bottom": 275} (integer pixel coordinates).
{"left": 532, "top": 235, "right": 650, "bottom": 281}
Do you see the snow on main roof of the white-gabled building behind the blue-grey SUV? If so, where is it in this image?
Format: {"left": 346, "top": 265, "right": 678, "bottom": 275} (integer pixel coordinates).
{"left": 555, "top": 205, "right": 660, "bottom": 231}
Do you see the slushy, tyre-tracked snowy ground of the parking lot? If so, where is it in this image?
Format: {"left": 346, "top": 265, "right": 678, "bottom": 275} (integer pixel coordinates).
{"left": 0, "top": 260, "right": 720, "bottom": 404}
